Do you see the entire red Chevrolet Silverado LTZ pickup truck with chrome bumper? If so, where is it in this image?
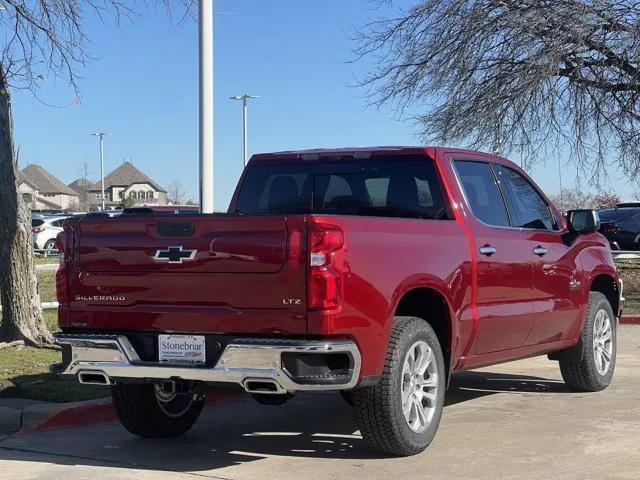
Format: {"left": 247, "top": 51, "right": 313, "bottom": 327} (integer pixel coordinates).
{"left": 56, "top": 147, "right": 622, "bottom": 455}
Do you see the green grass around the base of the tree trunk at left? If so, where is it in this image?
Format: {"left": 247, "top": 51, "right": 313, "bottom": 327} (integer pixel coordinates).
{"left": 0, "top": 310, "right": 109, "bottom": 402}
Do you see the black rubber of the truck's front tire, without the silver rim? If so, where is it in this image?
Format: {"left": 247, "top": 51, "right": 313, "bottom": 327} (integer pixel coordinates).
{"left": 560, "top": 292, "right": 618, "bottom": 392}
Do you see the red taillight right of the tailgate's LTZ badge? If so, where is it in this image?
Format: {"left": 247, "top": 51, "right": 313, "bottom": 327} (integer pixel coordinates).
{"left": 307, "top": 228, "right": 344, "bottom": 310}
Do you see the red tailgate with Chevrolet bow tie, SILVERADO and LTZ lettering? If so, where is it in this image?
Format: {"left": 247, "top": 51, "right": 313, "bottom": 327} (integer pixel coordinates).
{"left": 68, "top": 215, "right": 306, "bottom": 334}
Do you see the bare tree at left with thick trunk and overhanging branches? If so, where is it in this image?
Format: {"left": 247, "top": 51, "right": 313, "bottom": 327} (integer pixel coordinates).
{"left": 0, "top": 0, "right": 197, "bottom": 346}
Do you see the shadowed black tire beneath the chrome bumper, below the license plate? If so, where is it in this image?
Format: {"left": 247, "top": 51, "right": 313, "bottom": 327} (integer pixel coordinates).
{"left": 111, "top": 383, "right": 204, "bottom": 438}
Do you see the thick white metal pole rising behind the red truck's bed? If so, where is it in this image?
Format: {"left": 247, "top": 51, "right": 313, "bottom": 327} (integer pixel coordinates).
{"left": 199, "top": 0, "right": 214, "bottom": 213}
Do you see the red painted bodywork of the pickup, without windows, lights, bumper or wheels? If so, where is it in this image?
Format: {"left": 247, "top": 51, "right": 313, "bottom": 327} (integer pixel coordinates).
{"left": 59, "top": 147, "right": 618, "bottom": 382}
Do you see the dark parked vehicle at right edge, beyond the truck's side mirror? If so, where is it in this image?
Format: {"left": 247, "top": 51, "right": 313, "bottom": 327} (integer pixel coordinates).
{"left": 598, "top": 207, "right": 640, "bottom": 250}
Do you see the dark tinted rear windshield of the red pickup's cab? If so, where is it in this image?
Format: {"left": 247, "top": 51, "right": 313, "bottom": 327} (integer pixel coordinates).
{"left": 236, "top": 156, "right": 448, "bottom": 219}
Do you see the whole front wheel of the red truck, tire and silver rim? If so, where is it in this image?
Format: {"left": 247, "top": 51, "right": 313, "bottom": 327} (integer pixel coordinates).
{"left": 560, "top": 292, "right": 617, "bottom": 392}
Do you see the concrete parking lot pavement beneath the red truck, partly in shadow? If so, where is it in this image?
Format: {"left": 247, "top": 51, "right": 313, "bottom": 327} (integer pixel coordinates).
{"left": 0, "top": 326, "right": 640, "bottom": 480}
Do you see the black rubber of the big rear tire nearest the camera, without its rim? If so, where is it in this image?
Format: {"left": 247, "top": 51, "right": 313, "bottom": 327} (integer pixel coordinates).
{"left": 351, "top": 317, "right": 446, "bottom": 456}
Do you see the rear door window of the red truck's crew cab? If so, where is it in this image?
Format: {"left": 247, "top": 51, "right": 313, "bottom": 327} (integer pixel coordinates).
{"left": 454, "top": 160, "right": 510, "bottom": 227}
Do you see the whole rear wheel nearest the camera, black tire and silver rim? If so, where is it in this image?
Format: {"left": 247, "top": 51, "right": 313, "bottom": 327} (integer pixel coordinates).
{"left": 351, "top": 317, "right": 446, "bottom": 456}
